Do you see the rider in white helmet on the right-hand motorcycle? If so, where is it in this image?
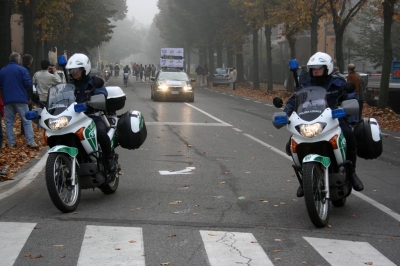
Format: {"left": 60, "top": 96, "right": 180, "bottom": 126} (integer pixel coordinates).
{"left": 283, "top": 52, "right": 364, "bottom": 197}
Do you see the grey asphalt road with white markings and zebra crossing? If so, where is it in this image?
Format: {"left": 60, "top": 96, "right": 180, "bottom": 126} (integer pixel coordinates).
{"left": 0, "top": 77, "right": 400, "bottom": 266}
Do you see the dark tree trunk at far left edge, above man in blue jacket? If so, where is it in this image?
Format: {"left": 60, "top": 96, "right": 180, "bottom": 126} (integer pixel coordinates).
{"left": 0, "top": 0, "right": 14, "bottom": 69}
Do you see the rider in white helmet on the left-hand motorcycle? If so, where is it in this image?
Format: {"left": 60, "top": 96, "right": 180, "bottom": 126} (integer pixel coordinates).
{"left": 65, "top": 53, "right": 117, "bottom": 173}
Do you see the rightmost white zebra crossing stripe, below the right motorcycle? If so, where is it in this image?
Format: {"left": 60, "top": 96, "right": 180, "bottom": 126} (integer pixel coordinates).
{"left": 303, "top": 237, "right": 396, "bottom": 266}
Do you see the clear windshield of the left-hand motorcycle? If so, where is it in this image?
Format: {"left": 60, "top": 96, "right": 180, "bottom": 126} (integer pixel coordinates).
{"left": 46, "top": 84, "right": 75, "bottom": 115}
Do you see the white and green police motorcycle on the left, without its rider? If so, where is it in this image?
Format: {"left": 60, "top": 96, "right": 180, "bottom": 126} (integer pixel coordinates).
{"left": 26, "top": 81, "right": 147, "bottom": 213}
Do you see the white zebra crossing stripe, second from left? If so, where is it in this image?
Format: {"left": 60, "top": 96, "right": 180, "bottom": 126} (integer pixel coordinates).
{"left": 78, "top": 225, "right": 145, "bottom": 266}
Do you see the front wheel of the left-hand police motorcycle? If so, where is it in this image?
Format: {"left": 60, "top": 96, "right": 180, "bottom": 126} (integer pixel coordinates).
{"left": 46, "top": 153, "right": 81, "bottom": 213}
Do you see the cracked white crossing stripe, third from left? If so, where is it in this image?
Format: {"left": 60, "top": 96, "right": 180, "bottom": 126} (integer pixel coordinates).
{"left": 200, "top": 231, "right": 273, "bottom": 266}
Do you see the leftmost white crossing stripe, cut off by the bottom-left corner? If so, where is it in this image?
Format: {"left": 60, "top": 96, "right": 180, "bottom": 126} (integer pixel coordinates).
{"left": 0, "top": 222, "right": 36, "bottom": 266}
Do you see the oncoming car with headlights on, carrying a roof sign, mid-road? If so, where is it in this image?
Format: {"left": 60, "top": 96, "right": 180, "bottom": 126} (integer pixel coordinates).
{"left": 151, "top": 69, "right": 196, "bottom": 102}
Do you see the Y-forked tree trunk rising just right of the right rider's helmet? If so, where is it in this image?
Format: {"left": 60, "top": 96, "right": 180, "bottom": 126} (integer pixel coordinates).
{"left": 328, "top": 0, "right": 368, "bottom": 69}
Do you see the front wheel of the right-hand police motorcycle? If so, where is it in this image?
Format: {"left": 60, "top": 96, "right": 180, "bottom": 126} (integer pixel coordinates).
{"left": 303, "top": 163, "right": 329, "bottom": 228}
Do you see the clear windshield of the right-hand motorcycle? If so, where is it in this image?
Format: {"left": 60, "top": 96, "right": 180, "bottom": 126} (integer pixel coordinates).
{"left": 295, "top": 87, "right": 328, "bottom": 121}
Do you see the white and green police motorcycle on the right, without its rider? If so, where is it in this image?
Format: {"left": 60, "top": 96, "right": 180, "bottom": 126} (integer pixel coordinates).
{"left": 273, "top": 59, "right": 382, "bottom": 228}
